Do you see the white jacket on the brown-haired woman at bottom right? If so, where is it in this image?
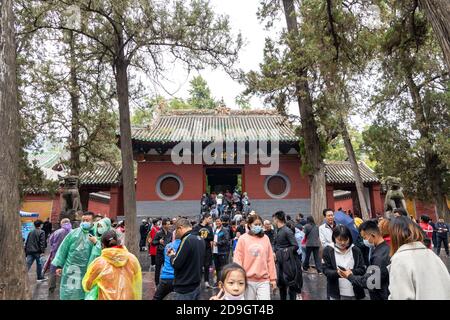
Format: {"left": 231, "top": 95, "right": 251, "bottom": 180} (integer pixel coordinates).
{"left": 388, "top": 242, "right": 450, "bottom": 300}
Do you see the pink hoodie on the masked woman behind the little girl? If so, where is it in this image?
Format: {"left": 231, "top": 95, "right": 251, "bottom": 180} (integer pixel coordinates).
{"left": 233, "top": 233, "right": 277, "bottom": 282}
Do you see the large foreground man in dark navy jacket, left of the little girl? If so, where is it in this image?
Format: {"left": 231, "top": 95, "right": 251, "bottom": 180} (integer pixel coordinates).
{"left": 167, "top": 218, "right": 205, "bottom": 300}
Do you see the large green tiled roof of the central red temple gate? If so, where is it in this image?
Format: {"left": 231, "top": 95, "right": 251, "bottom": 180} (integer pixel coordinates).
{"left": 132, "top": 109, "right": 299, "bottom": 143}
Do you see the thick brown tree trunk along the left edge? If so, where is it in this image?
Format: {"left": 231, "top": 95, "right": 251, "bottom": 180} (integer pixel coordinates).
{"left": 0, "top": 0, "right": 30, "bottom": 300}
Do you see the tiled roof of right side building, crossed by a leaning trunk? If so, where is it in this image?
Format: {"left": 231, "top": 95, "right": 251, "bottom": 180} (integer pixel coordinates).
{"left": 325, "top": 161, "right": 380, "bottom": 184}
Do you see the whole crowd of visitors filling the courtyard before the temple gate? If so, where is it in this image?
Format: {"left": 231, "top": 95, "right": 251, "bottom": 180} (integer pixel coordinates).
{"left": 25, "top": 202, "right": 450, "bottom": 300}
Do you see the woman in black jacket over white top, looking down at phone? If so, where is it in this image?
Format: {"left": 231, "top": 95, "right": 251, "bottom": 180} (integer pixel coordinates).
{"left": 323, "top": 225, "right": 365, "bottom": 300}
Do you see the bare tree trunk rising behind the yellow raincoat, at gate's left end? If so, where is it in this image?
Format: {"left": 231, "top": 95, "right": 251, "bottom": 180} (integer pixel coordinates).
{"left": 115, "top": 53, "right": 139, "bottom": 255}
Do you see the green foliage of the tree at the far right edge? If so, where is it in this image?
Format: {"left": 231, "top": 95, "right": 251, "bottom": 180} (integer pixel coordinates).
{"left": 363, "top": 0, "right": 450, "bottom": 200}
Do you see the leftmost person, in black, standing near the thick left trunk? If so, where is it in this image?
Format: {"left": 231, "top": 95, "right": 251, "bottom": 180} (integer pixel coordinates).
{"left": 25, "top": 220, "right": 47, "bottom": 281}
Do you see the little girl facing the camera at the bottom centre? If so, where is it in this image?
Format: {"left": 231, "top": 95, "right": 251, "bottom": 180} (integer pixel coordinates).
{"left": 210, "top": 263, "right": 247, "bottom": 300}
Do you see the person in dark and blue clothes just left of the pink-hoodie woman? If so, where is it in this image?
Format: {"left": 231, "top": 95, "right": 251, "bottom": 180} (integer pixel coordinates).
{"left": 212, "top": 218, "right": 230, "bottom": 287}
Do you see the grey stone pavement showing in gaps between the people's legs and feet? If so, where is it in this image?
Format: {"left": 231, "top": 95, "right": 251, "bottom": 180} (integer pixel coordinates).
{"left": 28, "top": 251, "right": 450, "bottom": 300}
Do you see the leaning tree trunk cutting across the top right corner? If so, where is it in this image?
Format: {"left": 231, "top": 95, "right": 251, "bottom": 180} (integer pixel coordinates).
{"left": 419, "top": 0, "right": 450, "bottom": 71}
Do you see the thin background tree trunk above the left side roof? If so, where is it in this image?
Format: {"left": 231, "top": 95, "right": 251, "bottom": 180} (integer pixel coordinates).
{"left": 68, "top": 31, "right": 81, "bottom": 176}
